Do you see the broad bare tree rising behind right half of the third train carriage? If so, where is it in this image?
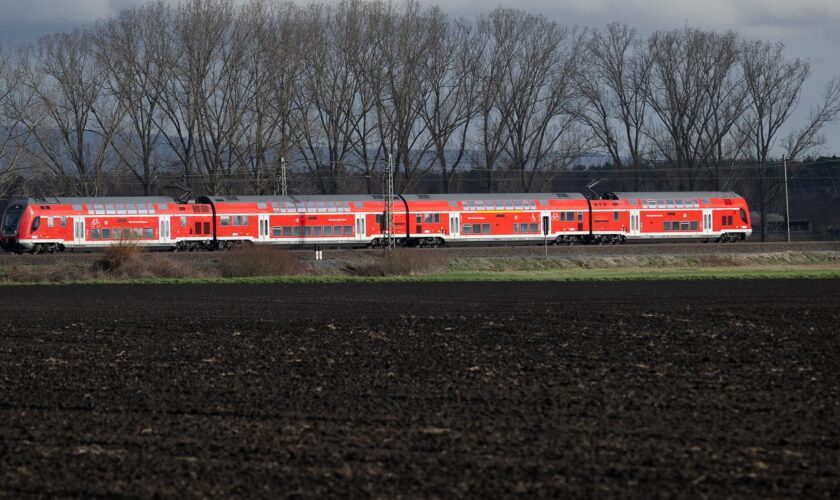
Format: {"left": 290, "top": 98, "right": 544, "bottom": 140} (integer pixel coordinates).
{"left": 476, "top": 9, "right": 586, "bottom": 191}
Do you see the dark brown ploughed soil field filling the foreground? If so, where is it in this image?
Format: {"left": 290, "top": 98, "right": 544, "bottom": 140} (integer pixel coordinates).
{"left": 0, "top": 280, "right": 840, "bottom": 498}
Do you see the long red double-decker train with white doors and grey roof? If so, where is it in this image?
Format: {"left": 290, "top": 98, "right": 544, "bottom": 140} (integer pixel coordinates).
{"left": 0, "top": 192, "right": 752, "bottom": 253}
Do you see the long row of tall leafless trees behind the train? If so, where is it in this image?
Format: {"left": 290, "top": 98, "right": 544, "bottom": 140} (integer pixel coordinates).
{"left": 0, "top": 0, "right": 840, "bottom": 230}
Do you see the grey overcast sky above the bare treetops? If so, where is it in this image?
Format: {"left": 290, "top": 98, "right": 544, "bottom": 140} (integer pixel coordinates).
{"left": 0, "top": 0, "right": 840, "bottom": 154}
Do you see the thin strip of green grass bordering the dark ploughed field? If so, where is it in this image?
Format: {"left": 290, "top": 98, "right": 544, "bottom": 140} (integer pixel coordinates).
{"left": 4, "top": 266, "right": 840, "bottom": 285}
